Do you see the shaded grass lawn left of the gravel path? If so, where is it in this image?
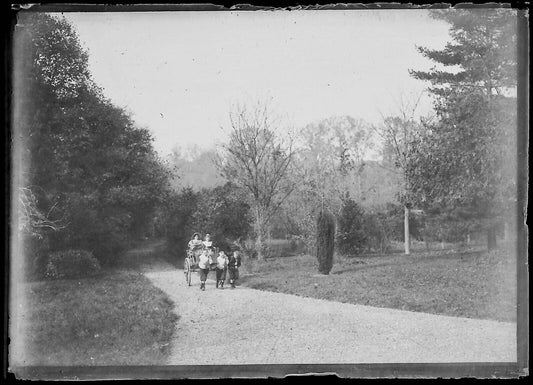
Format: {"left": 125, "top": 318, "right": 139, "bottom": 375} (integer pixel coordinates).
{"left": 16, "top": 242, "right": 178, "bottom": 366}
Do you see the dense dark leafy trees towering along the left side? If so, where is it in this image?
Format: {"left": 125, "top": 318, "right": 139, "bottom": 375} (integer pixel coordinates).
{"left": 15, "top": 13, "right": 168, "bottom": 263}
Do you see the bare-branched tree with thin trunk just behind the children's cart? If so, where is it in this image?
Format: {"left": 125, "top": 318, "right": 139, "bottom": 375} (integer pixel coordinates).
{"left": 218, "top": 101, "right": 294, "bottom": 259}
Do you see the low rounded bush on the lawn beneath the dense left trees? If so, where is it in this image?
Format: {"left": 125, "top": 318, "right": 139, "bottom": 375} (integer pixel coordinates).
{"left": 44, "top": 250, "right": 100, "bottom": 279}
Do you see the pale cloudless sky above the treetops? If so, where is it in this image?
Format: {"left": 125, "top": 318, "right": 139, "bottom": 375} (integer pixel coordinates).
{"left": 57, "top": 10, "right": 449, "bottom": 156}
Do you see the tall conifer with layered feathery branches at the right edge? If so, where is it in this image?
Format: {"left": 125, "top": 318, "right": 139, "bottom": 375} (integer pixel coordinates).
{"left": 408, "top": 9, "right": 517, "bottom": 249}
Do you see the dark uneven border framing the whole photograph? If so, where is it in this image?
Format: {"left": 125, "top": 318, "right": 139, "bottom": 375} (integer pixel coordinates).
{"left": 3, "top": 3, "right": 529, "bottom": 380}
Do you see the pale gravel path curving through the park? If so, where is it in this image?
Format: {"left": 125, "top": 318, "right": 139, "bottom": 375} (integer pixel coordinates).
{"left": 144, "top": 266, "right": 517, "bottom": 365}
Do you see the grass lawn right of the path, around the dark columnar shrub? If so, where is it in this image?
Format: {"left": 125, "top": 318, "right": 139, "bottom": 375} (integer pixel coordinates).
{"left": 240, "top": 244, "right": 516, "bottom": 321}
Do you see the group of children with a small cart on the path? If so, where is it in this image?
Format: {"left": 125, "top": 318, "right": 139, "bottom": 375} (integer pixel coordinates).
{"left": 189, "top": 233, "right": 241, "bottom": 290}
